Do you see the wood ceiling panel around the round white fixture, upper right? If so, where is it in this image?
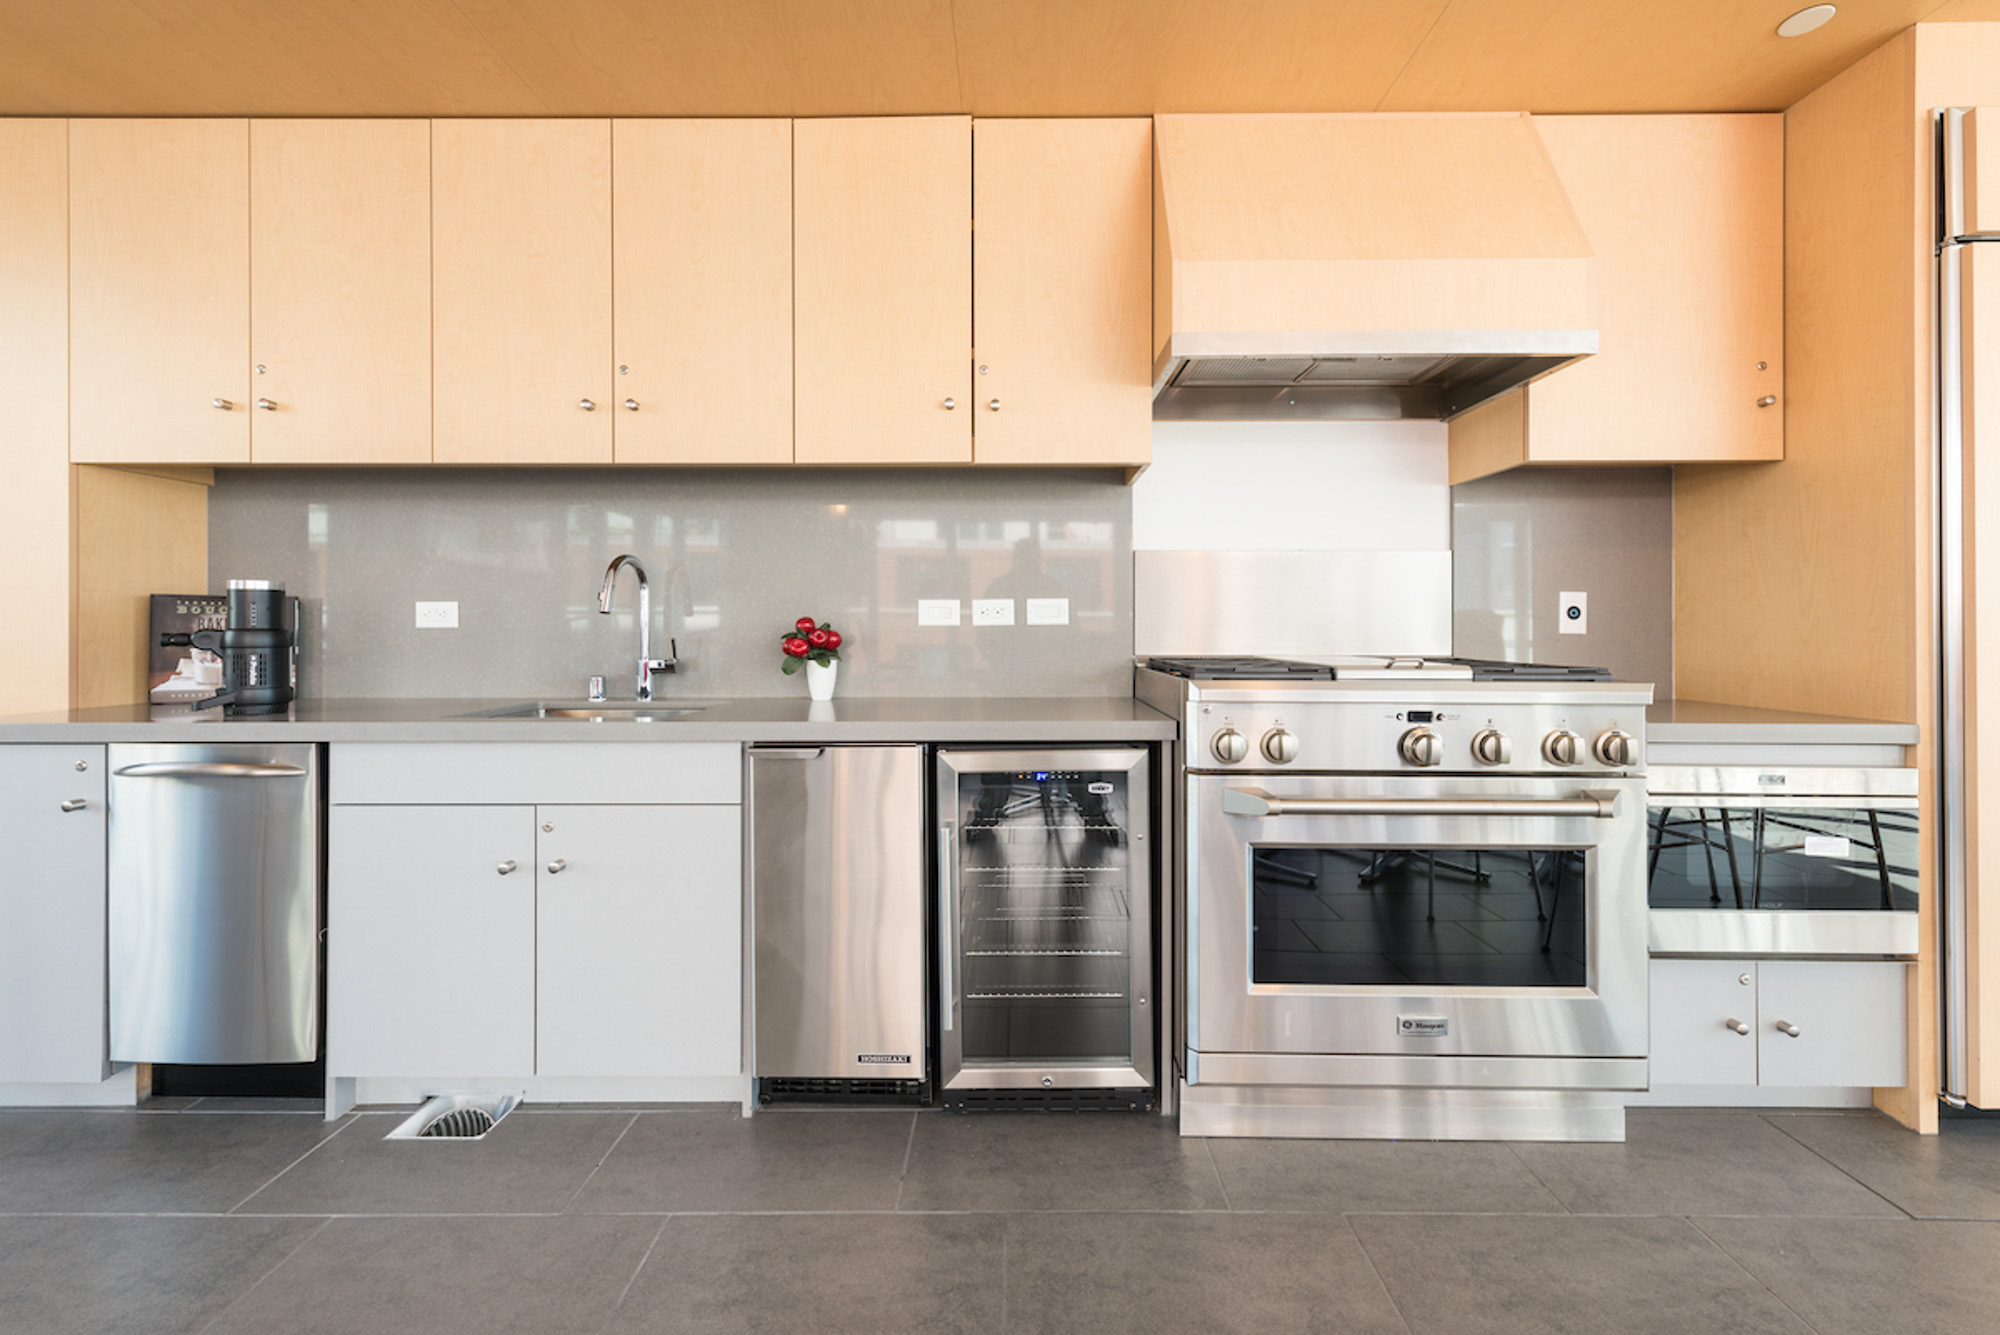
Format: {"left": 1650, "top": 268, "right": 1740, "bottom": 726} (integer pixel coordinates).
{"left": 1380, "top": 0, "right": 1938, "bottom": 112}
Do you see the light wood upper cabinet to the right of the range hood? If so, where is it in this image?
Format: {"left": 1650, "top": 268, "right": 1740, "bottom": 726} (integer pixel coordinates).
{"left": 1450, "top": 116, "right": 1784, "bottom": 484}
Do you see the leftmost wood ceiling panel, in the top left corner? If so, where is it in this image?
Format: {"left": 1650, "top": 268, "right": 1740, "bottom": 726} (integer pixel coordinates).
{"left": 0, "top": 0, "right": 548, "bottom": 116}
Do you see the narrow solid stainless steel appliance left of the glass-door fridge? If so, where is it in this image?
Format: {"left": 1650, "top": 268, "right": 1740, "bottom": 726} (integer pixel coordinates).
{"left": 744, "top": 745, "right": 930, "bottom": 1103}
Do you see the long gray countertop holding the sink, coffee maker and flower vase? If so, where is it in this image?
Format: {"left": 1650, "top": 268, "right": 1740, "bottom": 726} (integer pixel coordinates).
{"left": 0, "top": 695, "right": 1176, "bottom": 743}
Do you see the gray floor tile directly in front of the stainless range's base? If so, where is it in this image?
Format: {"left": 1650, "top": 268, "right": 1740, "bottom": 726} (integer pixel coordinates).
{"left": 1208, "top": 1139, "right": 1562, "bottom": 1215}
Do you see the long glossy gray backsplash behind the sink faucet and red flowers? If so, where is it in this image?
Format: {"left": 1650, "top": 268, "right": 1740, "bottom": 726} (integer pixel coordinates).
{"left": 215, "top": 470, "right": 1132, "bottom": 697}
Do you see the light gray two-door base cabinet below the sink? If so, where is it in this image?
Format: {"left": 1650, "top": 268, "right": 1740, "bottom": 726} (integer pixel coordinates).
{"left": 326, "top": 743, "right": 742, "bottom": 1079}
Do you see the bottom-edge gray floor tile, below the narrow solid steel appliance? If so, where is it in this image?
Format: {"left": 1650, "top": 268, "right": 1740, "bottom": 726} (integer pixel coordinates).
{"left": 606, "top": 1215, "right": 1006, "bottom": 1335}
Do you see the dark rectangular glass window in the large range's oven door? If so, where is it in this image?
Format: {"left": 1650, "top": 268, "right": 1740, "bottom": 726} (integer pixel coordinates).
{"left": 1250, "top": 845, "right": 1592, "bottom": 987}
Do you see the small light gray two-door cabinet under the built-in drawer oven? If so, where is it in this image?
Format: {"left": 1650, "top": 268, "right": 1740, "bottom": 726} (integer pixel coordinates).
{"left": 1652, "top": 959, "right": 1908, "bottom": 1087}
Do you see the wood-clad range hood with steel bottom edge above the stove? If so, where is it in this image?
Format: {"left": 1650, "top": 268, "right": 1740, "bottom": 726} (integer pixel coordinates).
{"left": 1152, "top": 112, "right": 1598, "bottom": 422}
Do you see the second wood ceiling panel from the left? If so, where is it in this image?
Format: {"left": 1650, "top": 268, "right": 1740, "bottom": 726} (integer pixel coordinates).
{"left": 458, "top": 0, "right": 962, "bottom": 116}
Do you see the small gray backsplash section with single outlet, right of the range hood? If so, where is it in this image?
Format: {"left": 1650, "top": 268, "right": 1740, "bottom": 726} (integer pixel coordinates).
{"left": 1452, "top": 468, "right": 1674, "bottom": 699}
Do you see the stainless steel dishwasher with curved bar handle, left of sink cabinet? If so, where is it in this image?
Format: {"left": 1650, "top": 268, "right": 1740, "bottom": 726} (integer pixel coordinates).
{"left": 106, "top": 743, "right": 324, "bottom": 1065}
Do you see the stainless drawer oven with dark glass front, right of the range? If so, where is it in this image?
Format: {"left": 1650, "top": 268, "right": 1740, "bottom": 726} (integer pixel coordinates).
{"left": 1646, "top": 765, "right": 1918, "bottom": 959}
